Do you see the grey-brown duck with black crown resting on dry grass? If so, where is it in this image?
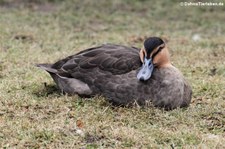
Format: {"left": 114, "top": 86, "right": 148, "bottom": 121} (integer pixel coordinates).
{"left": 37, "top": 37, "right": 192, "bottom": 110}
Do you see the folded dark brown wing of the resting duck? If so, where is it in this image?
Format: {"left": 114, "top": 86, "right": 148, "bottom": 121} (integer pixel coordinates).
{"left": 52, "top": 44, "right": 141, "bottom": 76}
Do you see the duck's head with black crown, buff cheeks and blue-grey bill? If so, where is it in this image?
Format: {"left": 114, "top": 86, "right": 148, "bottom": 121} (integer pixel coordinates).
{"left": 137, "top": 37, "right": 170, "bottom": 81}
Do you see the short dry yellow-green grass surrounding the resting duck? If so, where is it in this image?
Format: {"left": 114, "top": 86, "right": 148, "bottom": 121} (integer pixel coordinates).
{"left": 0, "top": 0, "right": 225, "bottom": 149}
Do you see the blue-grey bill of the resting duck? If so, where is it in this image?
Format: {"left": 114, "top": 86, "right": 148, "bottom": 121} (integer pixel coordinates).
{"left": 137, "top": 58, "right": 154, "bottom": 81}
